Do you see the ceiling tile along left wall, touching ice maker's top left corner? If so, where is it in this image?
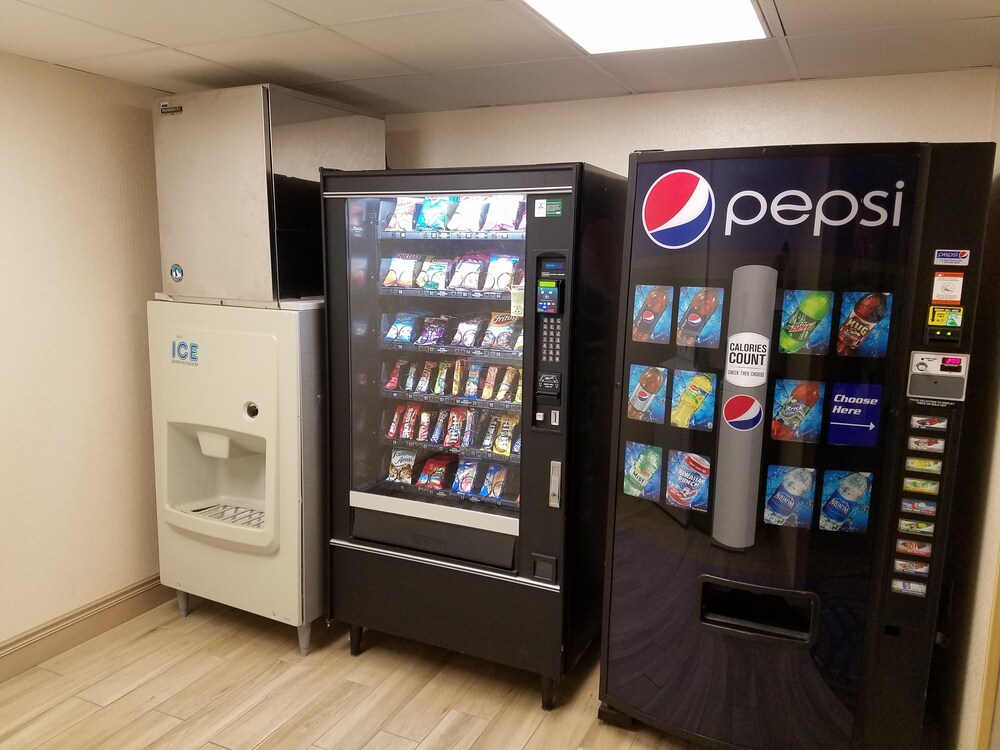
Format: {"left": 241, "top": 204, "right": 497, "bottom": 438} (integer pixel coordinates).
{"left": 61, "top": 48, "right": 260, "bottom": 94}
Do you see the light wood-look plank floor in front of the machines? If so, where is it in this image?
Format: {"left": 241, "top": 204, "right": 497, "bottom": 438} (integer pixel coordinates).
{"left": 0, "top": 597, "right": 694, "bottom": 750}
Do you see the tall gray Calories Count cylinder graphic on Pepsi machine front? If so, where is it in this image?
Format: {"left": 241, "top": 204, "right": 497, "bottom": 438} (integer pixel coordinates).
{"left": 712, "top": 266, "right": 778, "bottom": 549}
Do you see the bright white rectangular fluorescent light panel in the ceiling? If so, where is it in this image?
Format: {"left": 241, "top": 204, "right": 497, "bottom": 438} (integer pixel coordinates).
{"left": 524, "top": 0, "right": 767, "bottom": 54}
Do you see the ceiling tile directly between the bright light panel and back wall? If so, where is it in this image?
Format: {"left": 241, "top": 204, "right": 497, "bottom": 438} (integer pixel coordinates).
{"left": 593, "top": 39, "right": 793, "bottom": 93}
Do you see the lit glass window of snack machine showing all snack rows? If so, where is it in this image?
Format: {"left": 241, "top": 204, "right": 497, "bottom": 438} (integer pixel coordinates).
{"left": 347, "top": 193, "right": 525, "bottom": 517}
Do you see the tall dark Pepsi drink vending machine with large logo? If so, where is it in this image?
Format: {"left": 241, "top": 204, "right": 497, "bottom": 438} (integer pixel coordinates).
{"left": 600, "top": 143, "right": 995, "bottom": 750}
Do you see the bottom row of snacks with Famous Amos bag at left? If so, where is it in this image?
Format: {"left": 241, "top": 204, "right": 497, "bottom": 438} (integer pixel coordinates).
{"left": 386, "top": 448, "right": 521, "bottom": 505}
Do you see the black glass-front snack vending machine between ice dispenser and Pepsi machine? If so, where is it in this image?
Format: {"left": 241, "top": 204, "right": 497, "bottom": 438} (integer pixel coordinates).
{"left": 322, "top": 164, "right": 625, "bottom": 706}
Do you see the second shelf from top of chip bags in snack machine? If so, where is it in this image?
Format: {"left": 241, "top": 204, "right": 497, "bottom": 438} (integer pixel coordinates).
{"left": 382, "top": 251, "right": 524, "bottom": 292}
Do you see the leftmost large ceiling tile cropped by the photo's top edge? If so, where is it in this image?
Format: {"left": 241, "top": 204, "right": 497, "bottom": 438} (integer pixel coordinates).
{"left": 20, "top": 0, "right": 312, "bottom": 47}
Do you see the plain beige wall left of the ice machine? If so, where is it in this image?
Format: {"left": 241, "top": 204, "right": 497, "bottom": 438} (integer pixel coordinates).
{"left": 0, "top": 54, "right": 159, "bottom": 643}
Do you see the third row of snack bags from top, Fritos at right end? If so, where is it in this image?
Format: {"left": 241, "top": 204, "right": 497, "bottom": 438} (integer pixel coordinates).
{"left": 382, "top": 311, "right": 524, "bottom": 352}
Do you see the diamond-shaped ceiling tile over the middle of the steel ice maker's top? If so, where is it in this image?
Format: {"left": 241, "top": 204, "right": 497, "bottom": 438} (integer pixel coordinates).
{"left": 182, "top": 28, "right": 409, "bottom": 86}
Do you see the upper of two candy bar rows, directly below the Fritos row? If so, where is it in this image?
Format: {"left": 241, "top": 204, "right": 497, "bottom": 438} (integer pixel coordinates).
{"left": 383, "top": 357, "right": 521, "bottom": 404}
